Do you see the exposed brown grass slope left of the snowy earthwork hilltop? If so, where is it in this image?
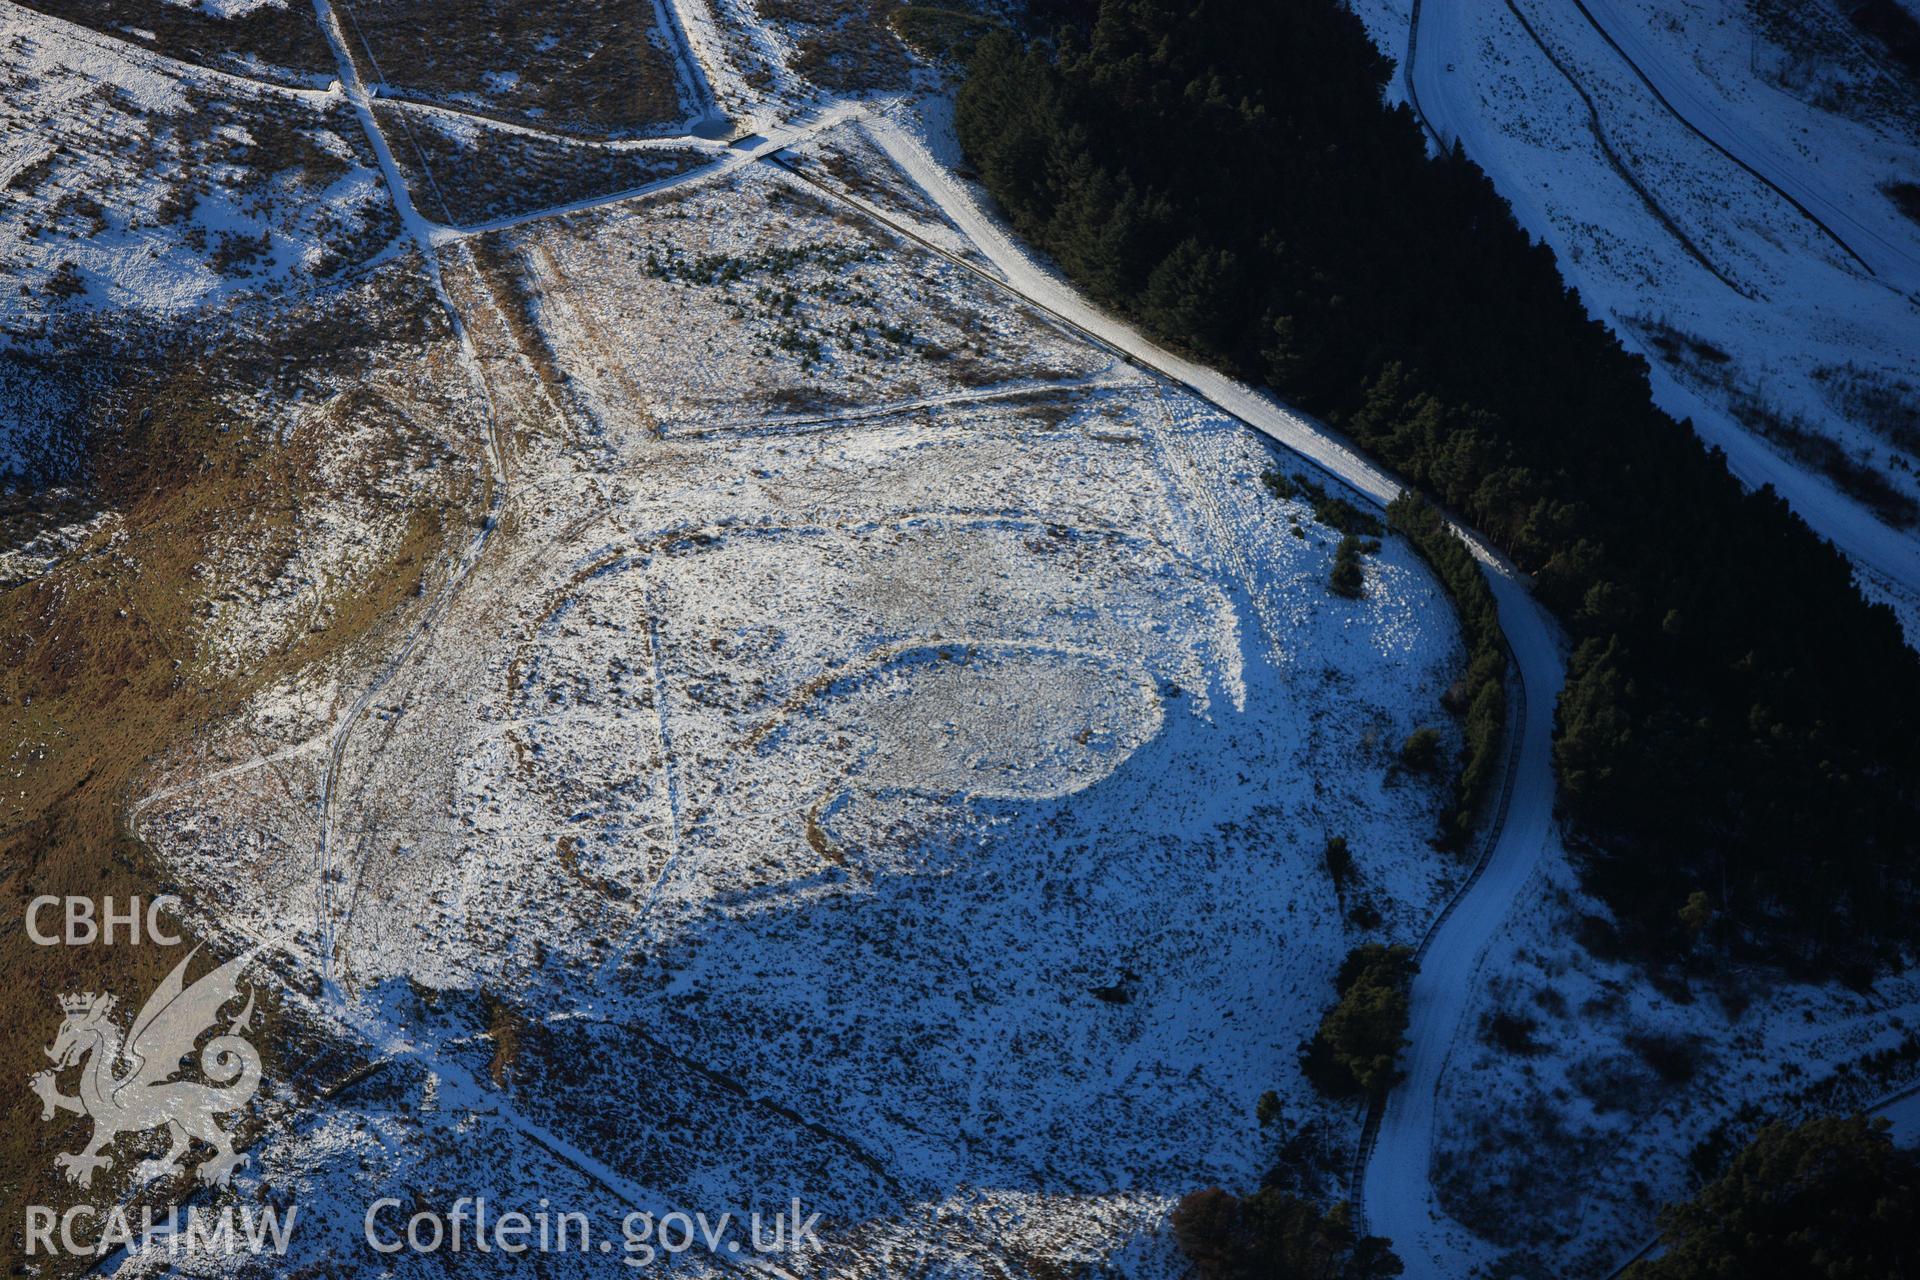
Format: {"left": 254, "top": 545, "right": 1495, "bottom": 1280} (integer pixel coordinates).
{"left": 0, "top": 280, "right": 487, "bottom": 1253}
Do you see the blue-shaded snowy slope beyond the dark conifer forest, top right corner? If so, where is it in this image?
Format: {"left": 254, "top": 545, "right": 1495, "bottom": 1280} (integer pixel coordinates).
{"left": 1354, "top": 0, "right": 1920, "bottom": 635}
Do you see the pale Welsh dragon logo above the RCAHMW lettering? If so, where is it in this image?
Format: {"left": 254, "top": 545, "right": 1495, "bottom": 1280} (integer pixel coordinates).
{"left": 29, "top": 946, "right": 259, "bottom": 1186}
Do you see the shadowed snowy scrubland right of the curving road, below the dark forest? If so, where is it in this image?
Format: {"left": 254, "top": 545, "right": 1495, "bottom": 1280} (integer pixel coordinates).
{"left": 1432, "top": 844, "right": 1920, "bottom": 1276}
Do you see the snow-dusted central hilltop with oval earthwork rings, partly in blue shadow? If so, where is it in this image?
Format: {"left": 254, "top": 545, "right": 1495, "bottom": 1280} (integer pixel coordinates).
{"left": 116, "top": 127, "right": 1463, "bottom": 1274}
